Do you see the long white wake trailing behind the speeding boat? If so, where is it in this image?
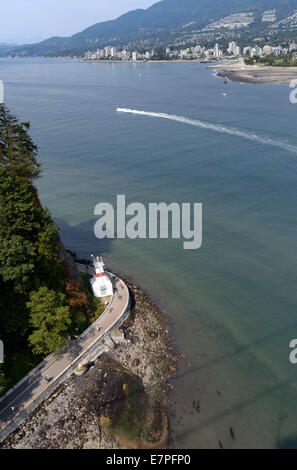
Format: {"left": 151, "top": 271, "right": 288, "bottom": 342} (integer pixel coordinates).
{"left": 117, "top": 108, "right": 297, "bottom": 154}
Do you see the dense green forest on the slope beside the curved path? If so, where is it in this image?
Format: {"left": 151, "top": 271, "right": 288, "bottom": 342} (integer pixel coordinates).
{"left": 0, "top": 105, "right": 102, "bottom": 395}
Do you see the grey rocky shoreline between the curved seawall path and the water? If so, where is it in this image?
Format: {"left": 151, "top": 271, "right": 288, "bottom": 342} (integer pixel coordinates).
{"left": 0, "top": 281, "right": 178, "bottom": 449}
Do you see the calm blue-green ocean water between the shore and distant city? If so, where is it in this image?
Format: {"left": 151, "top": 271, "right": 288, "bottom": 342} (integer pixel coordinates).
{"left": 0, "top": 59, "right": 297, "bottom": 448}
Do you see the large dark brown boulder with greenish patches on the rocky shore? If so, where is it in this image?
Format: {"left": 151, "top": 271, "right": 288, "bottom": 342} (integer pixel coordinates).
{"left": 76, "top": 354, "right": 168, "bottom": 448}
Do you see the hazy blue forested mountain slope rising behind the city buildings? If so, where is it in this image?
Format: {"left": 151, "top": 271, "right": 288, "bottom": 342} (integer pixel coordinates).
{"left": 5, "top": 0, "right": 297, "bottom": 55}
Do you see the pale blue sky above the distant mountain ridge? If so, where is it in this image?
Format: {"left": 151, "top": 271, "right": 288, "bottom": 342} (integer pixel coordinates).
{"left": 0, "top": 0, "right": 158, "bottom": 44}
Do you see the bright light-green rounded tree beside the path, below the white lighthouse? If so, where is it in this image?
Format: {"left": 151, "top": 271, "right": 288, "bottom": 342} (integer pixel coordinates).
{"left": 27, "top": 287, "right": 71, "bottom": 354}
